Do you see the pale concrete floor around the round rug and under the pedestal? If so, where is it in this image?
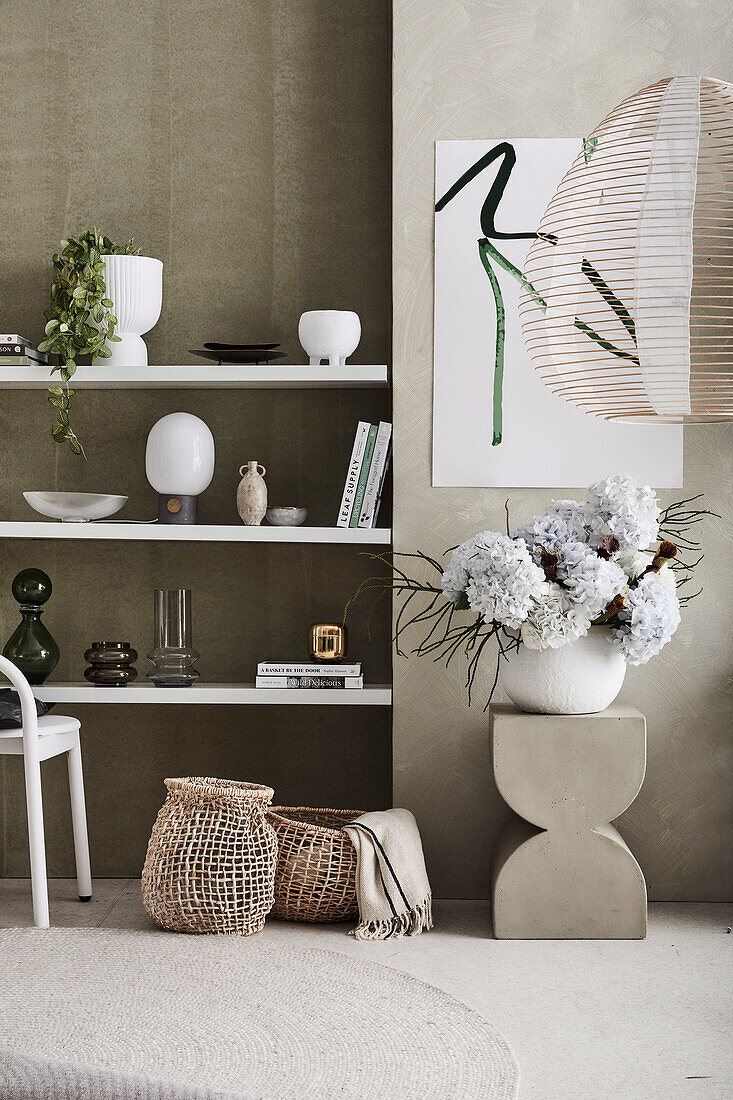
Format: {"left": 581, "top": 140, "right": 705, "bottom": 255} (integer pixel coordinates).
{"left": 0, "top": 879, "right": 733, "bottom": 1100}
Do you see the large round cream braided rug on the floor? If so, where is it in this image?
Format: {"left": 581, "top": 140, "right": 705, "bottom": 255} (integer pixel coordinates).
{"left": 0, "top": 928, "right": 518, "bottom": 1100}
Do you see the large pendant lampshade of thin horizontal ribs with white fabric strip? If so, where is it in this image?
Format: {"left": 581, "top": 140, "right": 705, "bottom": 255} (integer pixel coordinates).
{"left": 519, "top": 77, "right": 733, "bottom": 422}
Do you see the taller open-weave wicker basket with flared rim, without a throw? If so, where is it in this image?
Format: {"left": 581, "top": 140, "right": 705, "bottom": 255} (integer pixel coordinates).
{"left": 142, "top": 777, "right": 277, "bottom": 936}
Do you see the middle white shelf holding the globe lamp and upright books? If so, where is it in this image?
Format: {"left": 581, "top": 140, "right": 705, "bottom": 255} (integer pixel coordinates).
{"left": 0, "top": 520, "right": 392, "bottom": 546}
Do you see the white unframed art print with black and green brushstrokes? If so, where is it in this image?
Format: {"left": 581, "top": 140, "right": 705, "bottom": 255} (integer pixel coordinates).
{"left": 433, "top": 138, "right": 682, "bottom": 488}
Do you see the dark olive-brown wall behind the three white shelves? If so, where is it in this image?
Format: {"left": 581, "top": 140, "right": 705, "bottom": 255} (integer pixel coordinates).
{"left": 0, "top": 0, "right": 391, "bottom": 876}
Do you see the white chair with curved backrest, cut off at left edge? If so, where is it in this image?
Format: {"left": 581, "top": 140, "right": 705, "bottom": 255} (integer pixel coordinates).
{"left": 0, "top": 657, "right": 91, "bottom": 928}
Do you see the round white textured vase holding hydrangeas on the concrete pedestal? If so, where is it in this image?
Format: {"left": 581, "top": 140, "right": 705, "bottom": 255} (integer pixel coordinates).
{"left": 502, "top": 627, "right": 626, "bottom": 714}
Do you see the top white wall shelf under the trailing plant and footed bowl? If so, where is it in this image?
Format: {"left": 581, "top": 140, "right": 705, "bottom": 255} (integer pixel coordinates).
{"left": 0, "top": 361, "right": 387, "bottom": 389}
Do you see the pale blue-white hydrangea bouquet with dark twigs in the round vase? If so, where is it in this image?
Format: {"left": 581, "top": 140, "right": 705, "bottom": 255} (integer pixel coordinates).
{"left": 347, "top": 474, "right": 711, "bottom": 705}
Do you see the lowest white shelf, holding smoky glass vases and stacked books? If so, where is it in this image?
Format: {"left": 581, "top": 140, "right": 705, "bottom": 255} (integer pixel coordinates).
{"left": 33, "top": 681, "right": 392, "bottom": 706}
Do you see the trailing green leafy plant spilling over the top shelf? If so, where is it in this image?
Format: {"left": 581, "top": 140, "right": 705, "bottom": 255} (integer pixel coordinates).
{"left": 39, "top": 226, "right": 140, "bottom": 458}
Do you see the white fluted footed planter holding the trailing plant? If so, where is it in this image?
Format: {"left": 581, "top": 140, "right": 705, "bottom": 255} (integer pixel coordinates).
{"left": 94, "top": 255, "right": 163, "bottom": 366}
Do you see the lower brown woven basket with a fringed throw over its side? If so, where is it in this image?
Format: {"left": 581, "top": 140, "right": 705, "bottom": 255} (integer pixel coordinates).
{"left": 267, "top": 806, "right": 363, "bottom": 922}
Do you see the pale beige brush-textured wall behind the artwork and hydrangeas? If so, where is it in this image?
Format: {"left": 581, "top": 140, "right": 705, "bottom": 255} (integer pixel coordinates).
{"left": 393, "top": 0, "right": 733, "bottom": 900}
